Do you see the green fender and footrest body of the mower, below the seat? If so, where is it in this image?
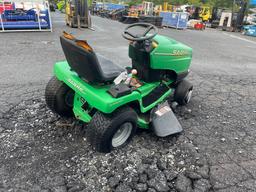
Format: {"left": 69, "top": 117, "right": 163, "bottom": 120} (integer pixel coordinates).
{"left": 54, "top": 61, "right": 174, "bottom": 128}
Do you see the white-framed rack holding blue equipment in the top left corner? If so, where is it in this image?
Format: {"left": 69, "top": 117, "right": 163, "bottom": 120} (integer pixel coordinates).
{"left": 0, "top": 0, "right": 52, "bottom": 32}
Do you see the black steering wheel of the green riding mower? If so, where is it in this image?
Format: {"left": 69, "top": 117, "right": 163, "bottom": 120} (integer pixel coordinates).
{"left": 122, "top": 23, "right": 158, "bottom": 41}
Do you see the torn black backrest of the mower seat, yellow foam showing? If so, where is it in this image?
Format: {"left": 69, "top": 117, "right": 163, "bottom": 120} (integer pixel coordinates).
{"left": 60, "top": 36, "right": 104, "bottom": 83}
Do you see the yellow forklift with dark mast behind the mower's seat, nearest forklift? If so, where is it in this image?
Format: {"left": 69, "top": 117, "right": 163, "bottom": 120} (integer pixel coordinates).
{"left": 65, "top": 0, "right": 91, "bottom": 28}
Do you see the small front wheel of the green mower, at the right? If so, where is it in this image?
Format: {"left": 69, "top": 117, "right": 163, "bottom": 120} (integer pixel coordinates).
{"left": 174, "top": 80, "right": 193, "bottom": 105}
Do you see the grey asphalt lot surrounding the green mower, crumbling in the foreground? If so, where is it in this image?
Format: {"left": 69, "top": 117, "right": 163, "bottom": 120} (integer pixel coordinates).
{"left": 0, "top": 13, "right": 256, "bottom": 192}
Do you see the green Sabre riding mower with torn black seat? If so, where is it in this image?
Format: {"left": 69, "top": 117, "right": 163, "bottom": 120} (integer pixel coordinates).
{"left": 45, "top": 23, "right": 193, "bottom": 153}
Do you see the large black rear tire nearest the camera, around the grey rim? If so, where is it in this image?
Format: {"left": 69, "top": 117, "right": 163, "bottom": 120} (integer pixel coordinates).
{"left": 87, "top": 107, "right": 137, "bottom": 153}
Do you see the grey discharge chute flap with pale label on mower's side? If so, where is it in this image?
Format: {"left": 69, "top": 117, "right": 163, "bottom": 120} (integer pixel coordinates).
{"left": 151, "top": 102, "right": 183, "bottom": 137}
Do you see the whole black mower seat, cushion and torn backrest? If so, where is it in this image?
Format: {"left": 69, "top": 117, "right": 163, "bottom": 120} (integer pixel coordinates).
{"left": 60, "top": 36, "right": 124, "bottom": 83}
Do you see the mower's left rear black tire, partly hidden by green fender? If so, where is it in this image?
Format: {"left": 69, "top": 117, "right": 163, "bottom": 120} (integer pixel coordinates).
{"left": 45, "top": 77, "right": 74, "bottom": 117}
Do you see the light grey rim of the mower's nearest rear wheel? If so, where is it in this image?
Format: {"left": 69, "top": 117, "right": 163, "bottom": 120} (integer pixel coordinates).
{"left": 112, "top": 122, "right": 133, "bottom": 148}
